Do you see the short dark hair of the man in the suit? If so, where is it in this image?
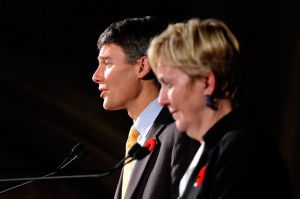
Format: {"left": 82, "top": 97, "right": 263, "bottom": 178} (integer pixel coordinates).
{"left": 97, "top": 16, "right": 167, "bottom": 64}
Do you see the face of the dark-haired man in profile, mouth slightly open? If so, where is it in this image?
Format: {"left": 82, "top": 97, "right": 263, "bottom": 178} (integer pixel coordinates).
{"left": 92, "top": 44, "right": 139, "bottom": 110}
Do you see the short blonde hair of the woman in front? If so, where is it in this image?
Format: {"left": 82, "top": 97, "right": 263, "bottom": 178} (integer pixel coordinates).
{"left": 147, "top": 18, "right": 239, "bottom": 98}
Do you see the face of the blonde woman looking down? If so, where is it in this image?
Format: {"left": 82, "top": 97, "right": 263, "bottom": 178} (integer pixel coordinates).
{"left": 157, "top": 63, "right": 205, "bottom": 139}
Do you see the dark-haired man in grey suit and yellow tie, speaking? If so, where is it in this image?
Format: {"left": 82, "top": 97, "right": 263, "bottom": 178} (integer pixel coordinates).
{"left": 93, "top": 17, "right": 199, "bottom": 199}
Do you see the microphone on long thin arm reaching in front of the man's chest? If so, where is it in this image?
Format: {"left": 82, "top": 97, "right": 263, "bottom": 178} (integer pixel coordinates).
{"left": 0, "top": 138, "right": 156, "bottom": 187}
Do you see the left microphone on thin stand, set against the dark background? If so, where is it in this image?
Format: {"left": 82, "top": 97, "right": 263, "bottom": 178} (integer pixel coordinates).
{"left": 0, "top": 143, "right": 86, "bottom": 194}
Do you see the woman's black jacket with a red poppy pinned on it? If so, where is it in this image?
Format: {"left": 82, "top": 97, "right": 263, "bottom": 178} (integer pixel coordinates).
{"left": 182, "top": 107, "right": 291, "bottom": 199}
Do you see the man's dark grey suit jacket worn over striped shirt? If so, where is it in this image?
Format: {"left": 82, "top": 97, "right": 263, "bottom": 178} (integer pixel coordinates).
{"left": 114, "top": 108, "right": 199, "bottom": 199}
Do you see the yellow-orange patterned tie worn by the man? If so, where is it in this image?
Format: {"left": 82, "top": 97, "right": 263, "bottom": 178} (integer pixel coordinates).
{"left": 122, "top": 125, "right": 140, "bottom": 198}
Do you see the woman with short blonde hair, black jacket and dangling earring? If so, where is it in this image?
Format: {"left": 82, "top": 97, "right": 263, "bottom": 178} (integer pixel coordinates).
{"left": 148, "top": 19, "right": 290, "bottom": 199}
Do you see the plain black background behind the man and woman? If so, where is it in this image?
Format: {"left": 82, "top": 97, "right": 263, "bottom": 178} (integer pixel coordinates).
{"left": 0, "top": 0, "right": 300, "bottom": 199}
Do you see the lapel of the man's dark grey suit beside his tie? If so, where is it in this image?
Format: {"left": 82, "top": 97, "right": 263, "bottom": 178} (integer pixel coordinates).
{"left": 125, "top": 108, "right": 170, "bottom": 199}
